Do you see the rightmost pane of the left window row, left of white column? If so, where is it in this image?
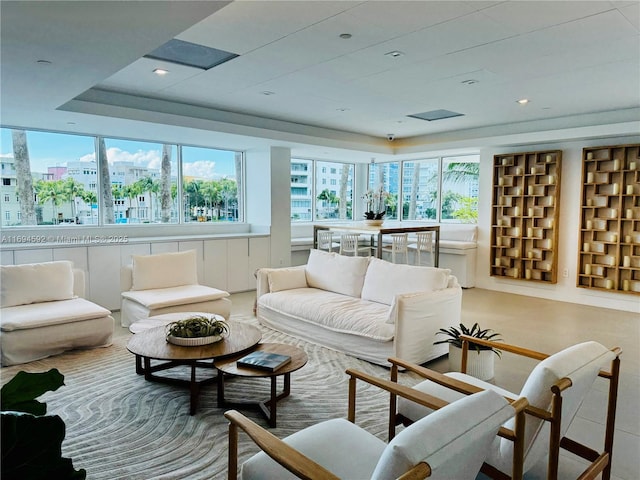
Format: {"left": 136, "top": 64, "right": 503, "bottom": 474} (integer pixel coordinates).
{"left": 182, "top": 147, "right": 242, "bottom": 222}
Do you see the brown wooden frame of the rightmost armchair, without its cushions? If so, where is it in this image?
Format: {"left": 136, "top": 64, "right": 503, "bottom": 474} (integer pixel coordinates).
{"left": 389, "top": 335, "right": 622, "bottom": 480}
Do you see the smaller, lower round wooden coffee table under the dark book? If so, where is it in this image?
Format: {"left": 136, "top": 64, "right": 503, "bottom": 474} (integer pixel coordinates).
{"left": 213, "top": 343, "right": 307, "bottom": 427}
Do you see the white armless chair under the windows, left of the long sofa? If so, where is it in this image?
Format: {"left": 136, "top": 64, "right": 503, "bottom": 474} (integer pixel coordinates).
{"left": 120, "top": 250, "right": 231, "bottom": 327}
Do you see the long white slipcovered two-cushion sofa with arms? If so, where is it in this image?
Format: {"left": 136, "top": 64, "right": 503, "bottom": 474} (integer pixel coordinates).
{"left": 256, "top": 250, "right": 462, "bottom": 366}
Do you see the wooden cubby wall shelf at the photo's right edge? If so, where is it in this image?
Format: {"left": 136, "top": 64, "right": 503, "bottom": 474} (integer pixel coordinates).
{"left": 577, "top": 145, "right": 640, "bottom": 295}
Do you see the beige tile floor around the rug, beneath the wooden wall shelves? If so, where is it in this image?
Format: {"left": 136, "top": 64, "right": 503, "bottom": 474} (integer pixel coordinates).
{"left": 116, "top": 288, "right": 640, "bottom": 480}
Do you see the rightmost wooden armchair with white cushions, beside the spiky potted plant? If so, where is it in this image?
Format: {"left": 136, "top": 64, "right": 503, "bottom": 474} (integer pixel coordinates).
{"left": 389, "top": 335, "right": 621, "bottom": 480}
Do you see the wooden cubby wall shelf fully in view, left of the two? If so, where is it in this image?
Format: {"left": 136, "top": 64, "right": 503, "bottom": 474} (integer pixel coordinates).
{"left": 490, "top": 150, "right": 562, "bottom": 283}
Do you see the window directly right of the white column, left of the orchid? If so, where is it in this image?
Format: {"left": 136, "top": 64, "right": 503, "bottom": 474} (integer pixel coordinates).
{"left": 291, "top": 158, "right": 354, "bottom": 222}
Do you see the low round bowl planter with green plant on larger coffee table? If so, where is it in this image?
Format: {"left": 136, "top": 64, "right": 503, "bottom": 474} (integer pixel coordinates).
{"left": 165, "top": 315, "right": 229, "bottom": 346}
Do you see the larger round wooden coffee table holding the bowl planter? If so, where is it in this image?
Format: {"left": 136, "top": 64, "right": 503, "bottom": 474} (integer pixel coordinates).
{"left": 127, "top": 320, "right": 262, "bottom": 415}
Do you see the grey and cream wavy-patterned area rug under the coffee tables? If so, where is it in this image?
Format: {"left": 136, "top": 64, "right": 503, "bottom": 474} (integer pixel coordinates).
{"left": 1, "top": 316, "right": 420, "bottom": 480}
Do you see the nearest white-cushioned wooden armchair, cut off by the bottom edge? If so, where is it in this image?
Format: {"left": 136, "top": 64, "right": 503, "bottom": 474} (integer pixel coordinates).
{"left": 225, "top": 369, "right": 526, "bottom": 480}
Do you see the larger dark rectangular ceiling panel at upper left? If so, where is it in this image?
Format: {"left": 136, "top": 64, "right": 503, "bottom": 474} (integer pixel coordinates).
{"left": 145, "top": 38, "right": 238, "bottom": 70}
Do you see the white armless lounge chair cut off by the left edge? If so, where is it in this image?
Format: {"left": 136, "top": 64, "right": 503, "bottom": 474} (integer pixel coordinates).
{"left": 0, "top": 261, "right": 114, "bottom": 366}
